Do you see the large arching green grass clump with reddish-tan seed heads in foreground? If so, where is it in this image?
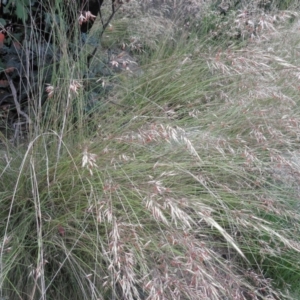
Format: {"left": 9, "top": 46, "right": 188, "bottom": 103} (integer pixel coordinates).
{"left": 0, "top": 0, "right": 300, "bottom": 300}
